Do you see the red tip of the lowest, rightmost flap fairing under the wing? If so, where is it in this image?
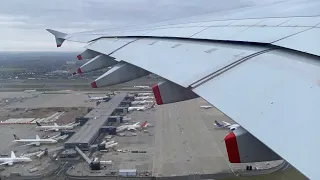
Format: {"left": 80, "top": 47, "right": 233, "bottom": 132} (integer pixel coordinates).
{"left": 224, "top": 132, "right": 240, "bottom": 163}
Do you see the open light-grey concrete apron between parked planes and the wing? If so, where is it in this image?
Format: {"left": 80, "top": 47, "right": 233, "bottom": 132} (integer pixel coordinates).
{"left": 153, "top": 99, "right": 232, "bottom": 176}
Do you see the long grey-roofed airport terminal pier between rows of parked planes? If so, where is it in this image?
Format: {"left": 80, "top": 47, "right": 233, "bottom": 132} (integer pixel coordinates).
{"left": 64, "top": 93, "right": 127, "bottom": 151}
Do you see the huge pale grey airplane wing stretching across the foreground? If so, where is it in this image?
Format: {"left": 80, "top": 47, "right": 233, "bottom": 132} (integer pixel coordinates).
{"left": 49, "top": 0, "right": 320, "bottom": 179}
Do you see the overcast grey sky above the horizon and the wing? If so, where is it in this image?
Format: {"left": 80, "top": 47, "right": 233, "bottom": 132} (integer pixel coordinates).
{"left": 0, "top": 0, "right": 280, "bottom": 51}
